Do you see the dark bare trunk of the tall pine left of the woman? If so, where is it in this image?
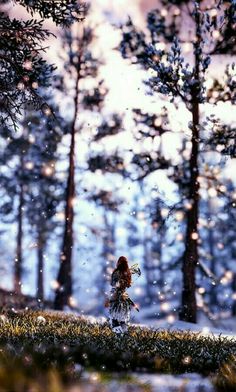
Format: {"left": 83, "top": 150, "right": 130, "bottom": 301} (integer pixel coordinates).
{"left": 54, "top": 70, "right": 80, "bottom": 310}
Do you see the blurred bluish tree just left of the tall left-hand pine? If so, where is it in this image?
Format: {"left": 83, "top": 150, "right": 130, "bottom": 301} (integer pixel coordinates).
{"left": 23, "top": 108, "right": 65, "bottom": 302}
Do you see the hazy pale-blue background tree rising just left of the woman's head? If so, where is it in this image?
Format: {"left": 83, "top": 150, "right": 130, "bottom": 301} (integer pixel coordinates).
{"left": 84, "top": 112, "right": 126, "bottom": 308}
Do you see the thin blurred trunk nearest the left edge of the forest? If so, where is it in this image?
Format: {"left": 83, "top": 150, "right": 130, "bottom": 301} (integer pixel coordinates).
{"left": 14, "top": 183, "right": 24, "bottom": 295}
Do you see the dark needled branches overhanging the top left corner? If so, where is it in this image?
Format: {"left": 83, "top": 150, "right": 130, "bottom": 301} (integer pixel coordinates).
{"left": 0, "top": 0, "right": 85, "bottom": 129}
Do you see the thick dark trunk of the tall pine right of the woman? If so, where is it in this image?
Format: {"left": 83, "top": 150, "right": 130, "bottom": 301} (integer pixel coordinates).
{"left": 179, "top": 1, "right": 201, "bottom": 323}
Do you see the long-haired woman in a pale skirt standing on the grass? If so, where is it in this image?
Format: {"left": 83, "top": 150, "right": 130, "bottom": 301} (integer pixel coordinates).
{"left": 107, "top": 256, "right": 141, "bottom": 333}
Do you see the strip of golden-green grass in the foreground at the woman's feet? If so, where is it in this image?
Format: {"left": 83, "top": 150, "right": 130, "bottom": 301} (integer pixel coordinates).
{"left": 0, "top": 311, "right": 236, "bottom": 391}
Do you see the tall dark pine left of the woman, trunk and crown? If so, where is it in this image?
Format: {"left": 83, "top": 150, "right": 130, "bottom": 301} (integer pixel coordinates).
{"left": 54, "top": 22, "right": 107, "bottom": 309}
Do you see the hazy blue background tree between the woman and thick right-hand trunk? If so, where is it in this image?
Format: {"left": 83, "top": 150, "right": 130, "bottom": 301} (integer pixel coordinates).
{"left": 130, "top": 108, "right": 171, "bottom": 304}
